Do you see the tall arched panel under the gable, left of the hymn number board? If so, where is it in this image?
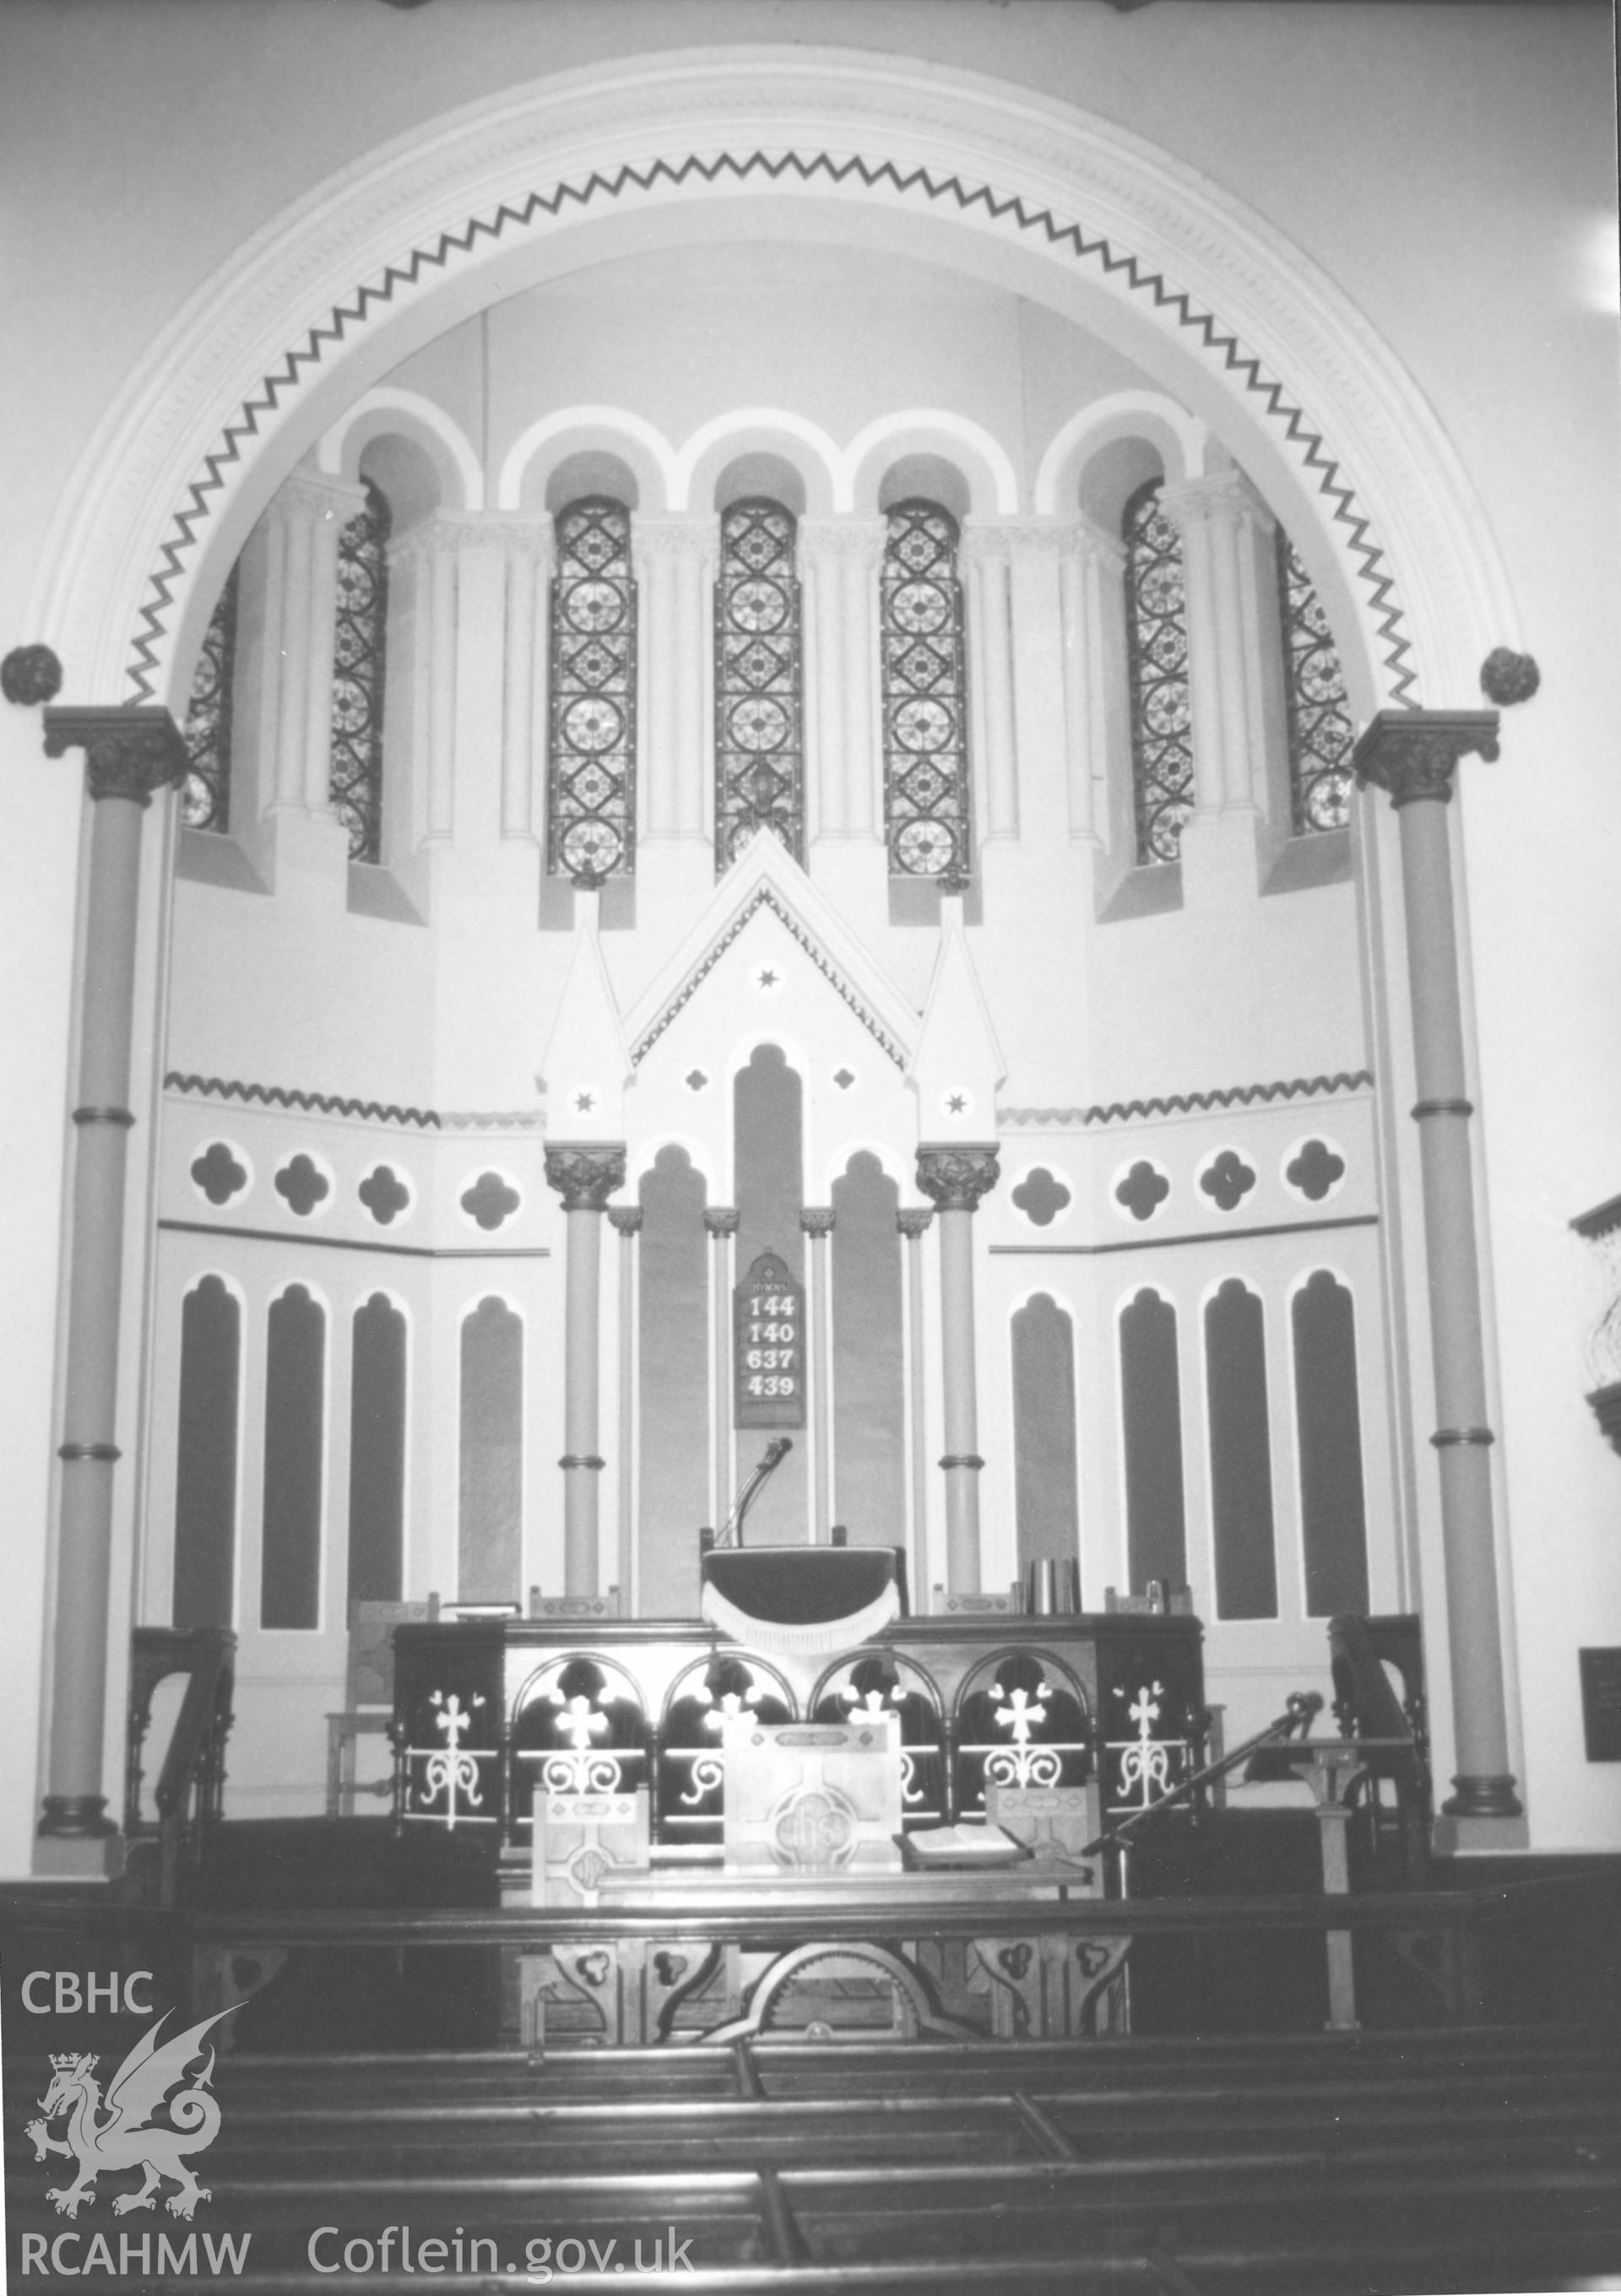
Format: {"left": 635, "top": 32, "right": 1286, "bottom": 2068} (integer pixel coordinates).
{"left": 636, "top": 1148, "right": 709, "bottom": 1619}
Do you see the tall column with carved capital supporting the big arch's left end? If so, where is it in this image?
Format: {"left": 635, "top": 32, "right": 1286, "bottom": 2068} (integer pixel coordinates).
{"left": 35, "top": 707, "right": 186, "bottom": 1876}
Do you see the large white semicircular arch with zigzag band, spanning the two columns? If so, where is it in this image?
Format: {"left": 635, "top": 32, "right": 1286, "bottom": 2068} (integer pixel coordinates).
{"left": 39, "top": 48, "right": 1515, "bottom": 707}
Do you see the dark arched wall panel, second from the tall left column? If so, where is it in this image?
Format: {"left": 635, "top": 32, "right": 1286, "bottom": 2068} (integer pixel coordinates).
{"left": 259, "top": 1283, "right": 326, "bottom": 1633}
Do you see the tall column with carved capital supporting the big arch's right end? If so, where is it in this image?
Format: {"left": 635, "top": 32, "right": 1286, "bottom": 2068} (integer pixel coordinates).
{"left": 1353, "top": 709, "right": 1522, "bottom": 1849}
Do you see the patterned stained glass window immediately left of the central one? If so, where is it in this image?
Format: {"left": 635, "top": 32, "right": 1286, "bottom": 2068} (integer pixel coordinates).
{"left": 546, "top": 494, "right": 636, "bottom": 884}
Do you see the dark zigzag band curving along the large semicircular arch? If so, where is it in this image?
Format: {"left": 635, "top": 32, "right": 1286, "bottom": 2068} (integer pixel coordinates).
{"left": 128, "top": 152, "right": 1417, "bottom": 707}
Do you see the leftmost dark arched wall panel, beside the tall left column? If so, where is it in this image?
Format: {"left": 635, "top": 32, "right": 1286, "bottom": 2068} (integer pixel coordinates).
{"left": 172, "top": 1276, "right": 241, "bottom": 1626}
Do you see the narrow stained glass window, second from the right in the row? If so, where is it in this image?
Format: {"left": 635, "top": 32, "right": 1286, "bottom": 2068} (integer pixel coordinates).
{"left": 1120, "top": 479, "right": 1194, "bottom": 864}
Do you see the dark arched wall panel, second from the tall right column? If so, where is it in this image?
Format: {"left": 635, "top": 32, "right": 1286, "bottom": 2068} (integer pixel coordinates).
{"left": 1206, "top": 1276, "right": 1277, "bottom": 1619}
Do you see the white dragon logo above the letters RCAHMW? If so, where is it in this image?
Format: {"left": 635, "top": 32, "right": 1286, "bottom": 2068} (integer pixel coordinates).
{"left": 28, "top": 2009, "right": 230, "bottom": 2216}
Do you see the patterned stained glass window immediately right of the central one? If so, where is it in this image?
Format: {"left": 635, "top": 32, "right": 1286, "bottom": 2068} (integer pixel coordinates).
{"left": 880, "top": 503, "right": 969, "bottom": 877}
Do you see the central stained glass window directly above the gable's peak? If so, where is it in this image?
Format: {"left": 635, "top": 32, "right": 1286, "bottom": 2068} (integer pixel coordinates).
{"left": 714, "top": 501, "right": 804, "bottom": 870}
